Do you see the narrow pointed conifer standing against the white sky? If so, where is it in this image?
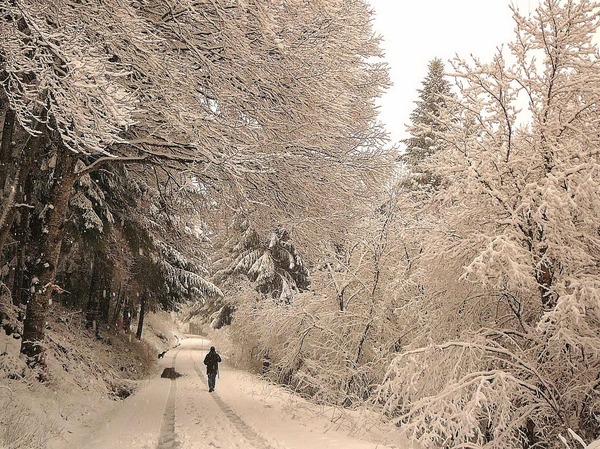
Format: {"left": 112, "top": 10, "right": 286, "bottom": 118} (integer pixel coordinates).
{"left": 401, "top": 58, "right": 452, "bottom": 184}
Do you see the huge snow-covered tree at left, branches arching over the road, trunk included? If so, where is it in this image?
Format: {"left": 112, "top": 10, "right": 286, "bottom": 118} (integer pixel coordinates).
{"left": 0, "top": 0, "right": 387, "bottom": 364}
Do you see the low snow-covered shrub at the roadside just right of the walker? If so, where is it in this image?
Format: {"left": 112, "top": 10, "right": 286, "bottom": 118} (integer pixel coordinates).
{"left": 229, "top": 293, "right": 398, "bottom": 406}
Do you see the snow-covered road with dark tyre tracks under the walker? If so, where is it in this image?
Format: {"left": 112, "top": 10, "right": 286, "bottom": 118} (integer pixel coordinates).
{"left": 51, "top": 336, "right": 411, "bottom": 449}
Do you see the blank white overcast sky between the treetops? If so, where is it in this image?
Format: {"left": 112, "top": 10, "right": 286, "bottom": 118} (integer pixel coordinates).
{"left": 369, "top": 0, "right": 539, "bottom": 141}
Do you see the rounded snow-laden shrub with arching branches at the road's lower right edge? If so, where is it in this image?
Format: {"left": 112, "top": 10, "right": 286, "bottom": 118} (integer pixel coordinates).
{"left": 378, "top": 334, "right": 559, "bottom": 449}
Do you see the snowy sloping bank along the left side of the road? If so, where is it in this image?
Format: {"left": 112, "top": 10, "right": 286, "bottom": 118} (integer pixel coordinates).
{"left": 0, "top": 305, "right": 179, "bottom": 449}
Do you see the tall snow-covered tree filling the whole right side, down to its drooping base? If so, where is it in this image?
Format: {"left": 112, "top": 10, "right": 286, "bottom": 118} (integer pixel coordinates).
{"left": 380, "top": 0, "right": 600, "bottom": 448}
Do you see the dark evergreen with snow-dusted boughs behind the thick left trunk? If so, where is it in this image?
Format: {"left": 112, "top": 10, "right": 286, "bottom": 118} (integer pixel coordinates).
{"left": 59, "top": 161, "right": 221, "bottom": 336}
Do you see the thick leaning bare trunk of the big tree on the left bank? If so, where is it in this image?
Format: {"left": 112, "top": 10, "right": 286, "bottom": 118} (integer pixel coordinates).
{"left": 21, "top": 148, "right": 77, "bottom": 368}
